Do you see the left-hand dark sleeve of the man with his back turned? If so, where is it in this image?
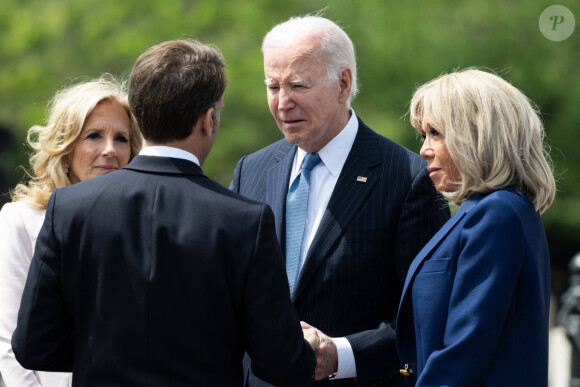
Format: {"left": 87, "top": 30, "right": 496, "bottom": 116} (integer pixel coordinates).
{"left": 12, "top": 190, "right": 73, "bottom": 372}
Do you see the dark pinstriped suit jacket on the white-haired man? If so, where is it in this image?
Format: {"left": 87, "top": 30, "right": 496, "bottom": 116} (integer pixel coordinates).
{"left": 230, "top": 119, "right": 449, "bottom": 386}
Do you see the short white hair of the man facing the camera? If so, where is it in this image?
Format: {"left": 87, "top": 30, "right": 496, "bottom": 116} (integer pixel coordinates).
{"left": 262, "top": 15, "right": 358, "bottom": 107}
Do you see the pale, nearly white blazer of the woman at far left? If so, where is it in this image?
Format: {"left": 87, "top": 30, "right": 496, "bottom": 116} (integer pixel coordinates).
{"left": 0, "top": 202, "right": 72, "bottom": 387}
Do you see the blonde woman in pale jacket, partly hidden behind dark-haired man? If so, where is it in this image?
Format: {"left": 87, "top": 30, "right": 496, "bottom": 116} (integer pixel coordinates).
{"left": 0, "top": 74, "right": 142, "bottom": 387}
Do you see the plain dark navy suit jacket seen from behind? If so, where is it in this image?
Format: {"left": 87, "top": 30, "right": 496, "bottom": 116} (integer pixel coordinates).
{"left": 12, "top": 156, "right": 315, "bottom": 387}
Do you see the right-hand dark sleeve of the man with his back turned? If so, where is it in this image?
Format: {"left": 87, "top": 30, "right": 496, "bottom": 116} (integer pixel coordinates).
{"left": 243, "top": 204, "right": 316, "bottom": 386}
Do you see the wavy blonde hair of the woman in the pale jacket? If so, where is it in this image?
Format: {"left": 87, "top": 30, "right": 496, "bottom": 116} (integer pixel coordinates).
{"left": 11, "top": 74, "right": 142, "bottom": 210}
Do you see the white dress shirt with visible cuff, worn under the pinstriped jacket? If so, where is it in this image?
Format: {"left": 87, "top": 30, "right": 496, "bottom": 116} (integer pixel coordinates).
{"left": 289, "top": 109, "right": 358, "bottom": 379}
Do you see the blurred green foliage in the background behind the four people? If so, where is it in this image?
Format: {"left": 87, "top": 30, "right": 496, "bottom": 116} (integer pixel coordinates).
{"left": 0, "top": 0, "right": 580, "bottom": 293}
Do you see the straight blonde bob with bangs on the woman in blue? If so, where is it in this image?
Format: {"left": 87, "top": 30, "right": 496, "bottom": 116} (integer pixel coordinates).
{"left": 410, "top": 68, "right": 556, "bottom": 214}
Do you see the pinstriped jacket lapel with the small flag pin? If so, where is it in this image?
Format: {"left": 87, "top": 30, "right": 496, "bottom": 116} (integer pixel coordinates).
{"left": 292, "top": 123, "right": 382, "bottom": 300}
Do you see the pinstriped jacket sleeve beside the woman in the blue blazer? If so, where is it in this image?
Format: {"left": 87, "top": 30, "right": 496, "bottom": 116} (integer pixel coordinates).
{"left": 347, "top": 168, "right": 450, "bottom": 385}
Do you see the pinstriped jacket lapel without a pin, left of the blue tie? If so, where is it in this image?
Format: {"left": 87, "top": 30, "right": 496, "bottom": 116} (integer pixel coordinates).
{"left": 266, "top": 142, "right": 296, "bottom": 247}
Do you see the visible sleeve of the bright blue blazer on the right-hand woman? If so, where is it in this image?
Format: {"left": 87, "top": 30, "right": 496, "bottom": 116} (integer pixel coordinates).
{"left": 413, "top": 203, "right": 539, "bottom": 386}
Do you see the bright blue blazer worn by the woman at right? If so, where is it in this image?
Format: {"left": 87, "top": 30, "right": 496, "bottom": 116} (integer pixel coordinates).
{"left": 397, "top": 189, "right": 550, "bottom": 387}
